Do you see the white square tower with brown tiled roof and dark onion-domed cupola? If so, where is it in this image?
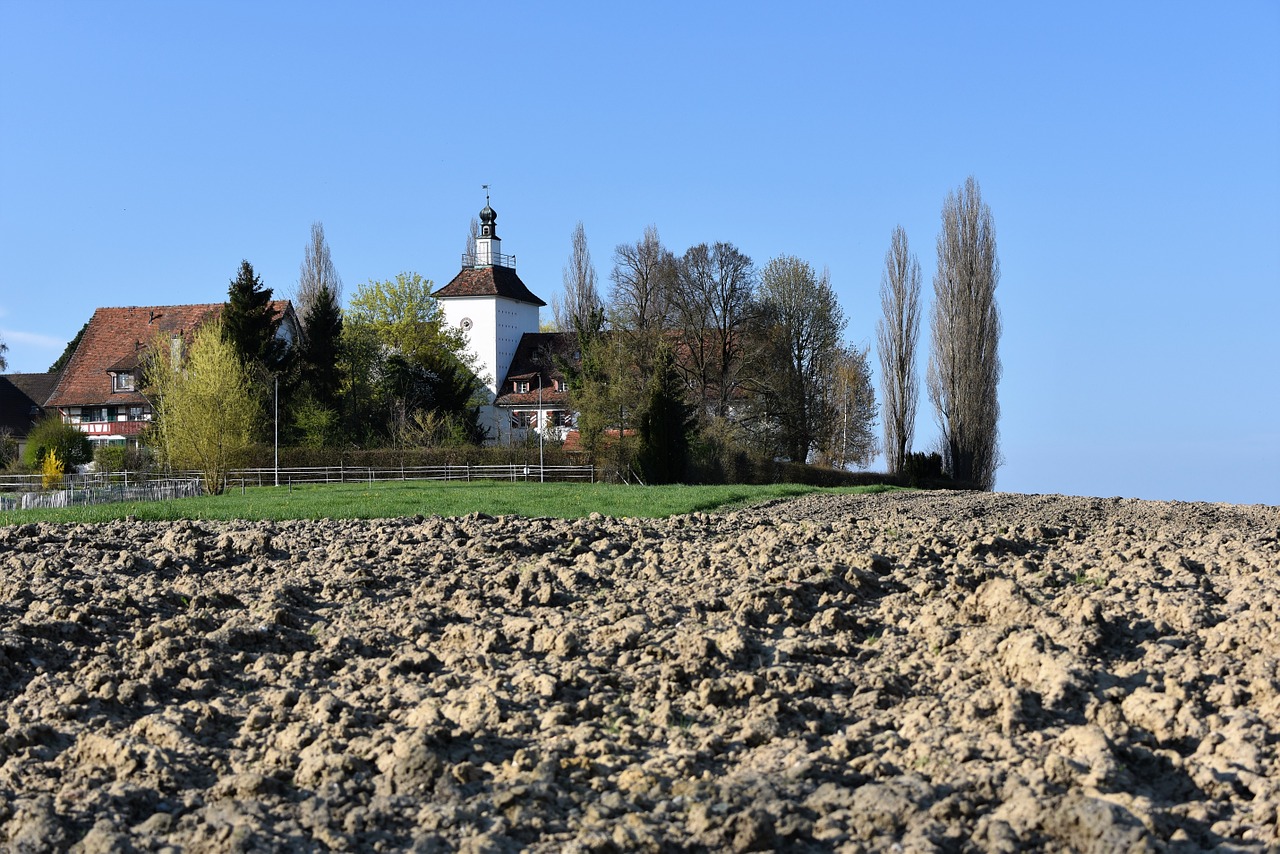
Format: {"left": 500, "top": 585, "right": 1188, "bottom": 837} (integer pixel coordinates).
{"left": 435, "top": 193, "right": 547, "bottom": 439}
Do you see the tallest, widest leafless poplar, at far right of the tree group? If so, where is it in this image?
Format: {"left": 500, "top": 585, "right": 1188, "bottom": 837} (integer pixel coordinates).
{"left": 928, "top": 175, "right": 1000, "bottom": 489}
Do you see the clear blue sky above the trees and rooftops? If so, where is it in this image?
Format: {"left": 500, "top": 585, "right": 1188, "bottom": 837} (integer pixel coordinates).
{"left": 0, "top": 0, "right": 1280, "bottom": 503}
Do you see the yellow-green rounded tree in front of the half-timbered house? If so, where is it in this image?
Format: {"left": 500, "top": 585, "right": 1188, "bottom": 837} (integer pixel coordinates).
{"left": 147, "top": 321, "right": 259, "bottom": 495}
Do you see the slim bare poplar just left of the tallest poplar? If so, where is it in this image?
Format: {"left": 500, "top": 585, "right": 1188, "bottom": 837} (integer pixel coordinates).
{"left": 876, "top": 225, "right": 920, "bottom": 474}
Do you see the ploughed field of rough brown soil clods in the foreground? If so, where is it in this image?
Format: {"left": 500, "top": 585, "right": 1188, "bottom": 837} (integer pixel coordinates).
{"left": 0, "top": 493, "right": 1280, "bottom": 853}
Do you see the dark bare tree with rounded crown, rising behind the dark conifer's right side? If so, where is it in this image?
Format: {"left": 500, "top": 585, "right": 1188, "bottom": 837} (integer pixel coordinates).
{"left": 672, "top": 242, "right": 758, "bottom": 419}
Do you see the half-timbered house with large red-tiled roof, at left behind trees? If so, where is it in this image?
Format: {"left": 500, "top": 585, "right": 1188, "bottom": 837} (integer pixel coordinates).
{"left": 45, "top": 300, "right": 300, "bottom": 447}
